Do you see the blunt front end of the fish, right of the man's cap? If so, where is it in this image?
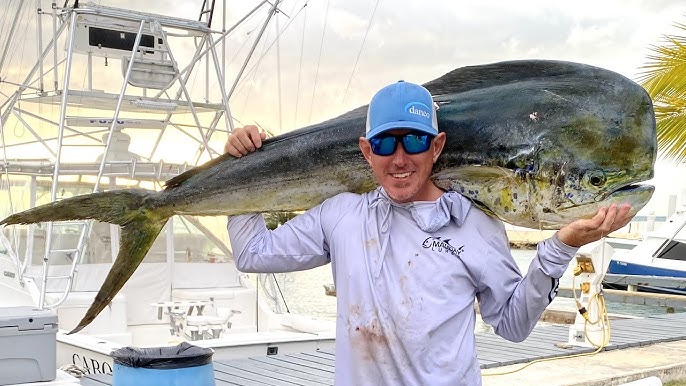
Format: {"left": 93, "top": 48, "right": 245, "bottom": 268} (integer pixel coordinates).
{"left": 429, "top": 61, "right": 657, "bottom": 229}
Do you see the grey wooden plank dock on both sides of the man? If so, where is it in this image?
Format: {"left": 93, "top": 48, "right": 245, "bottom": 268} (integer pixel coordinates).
{"left": 81, "top": 313, "right": 686, "bottom": 386}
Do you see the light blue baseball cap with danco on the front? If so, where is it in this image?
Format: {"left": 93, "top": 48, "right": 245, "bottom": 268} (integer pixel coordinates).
{"left": 366, "top": 80, "right": 438, "bottom": 139}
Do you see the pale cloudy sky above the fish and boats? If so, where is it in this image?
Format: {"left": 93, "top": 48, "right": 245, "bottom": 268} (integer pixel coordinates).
{"left": 0, "top": 0, "right": 686, "bottom": 213}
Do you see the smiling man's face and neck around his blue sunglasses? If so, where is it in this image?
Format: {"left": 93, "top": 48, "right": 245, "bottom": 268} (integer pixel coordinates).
{"left": 359, "top": 129, "right": 445, "bottom": 203}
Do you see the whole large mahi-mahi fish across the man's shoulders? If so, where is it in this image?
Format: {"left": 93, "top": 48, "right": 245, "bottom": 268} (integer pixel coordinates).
{"left": 0, "top": 60, "right": 657, "bottom": 333}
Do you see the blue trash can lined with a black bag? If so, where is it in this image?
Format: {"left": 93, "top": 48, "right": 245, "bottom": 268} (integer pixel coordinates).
{"left": 110, "top": 342, "right": 215, "bottom": 386}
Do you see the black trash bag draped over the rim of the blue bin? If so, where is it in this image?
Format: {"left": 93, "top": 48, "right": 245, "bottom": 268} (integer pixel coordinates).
{"left": 110, "top": 342, "right": 214, "bottom": 370}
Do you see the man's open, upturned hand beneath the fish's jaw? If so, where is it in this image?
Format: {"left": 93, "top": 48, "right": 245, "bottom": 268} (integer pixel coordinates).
{"left": 557, "top": 204, "right": 633, "bottom": 247}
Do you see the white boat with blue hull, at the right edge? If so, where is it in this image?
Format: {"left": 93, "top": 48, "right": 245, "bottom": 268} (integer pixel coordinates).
{"left": 603, "top": 206, "right": 686, "bottom": 295}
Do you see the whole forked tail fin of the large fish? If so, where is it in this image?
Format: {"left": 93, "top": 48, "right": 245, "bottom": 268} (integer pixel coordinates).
{"left": 0, "top": 189, "right": 172, "bottom": 334}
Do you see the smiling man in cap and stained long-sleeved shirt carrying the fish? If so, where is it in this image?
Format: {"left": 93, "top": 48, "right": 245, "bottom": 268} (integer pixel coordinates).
{"left": 225, "top": 81, "right": 630, "bottom": 386}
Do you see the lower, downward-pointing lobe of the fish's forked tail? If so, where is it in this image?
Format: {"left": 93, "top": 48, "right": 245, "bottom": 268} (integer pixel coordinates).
{"left": 69, "top": 215, "right": 168, "bottom": 334}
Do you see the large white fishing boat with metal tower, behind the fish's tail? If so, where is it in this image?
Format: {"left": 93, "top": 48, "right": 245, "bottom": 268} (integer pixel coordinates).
{"left": 0, "top": 0, "right": 335, "bottom": 374}
